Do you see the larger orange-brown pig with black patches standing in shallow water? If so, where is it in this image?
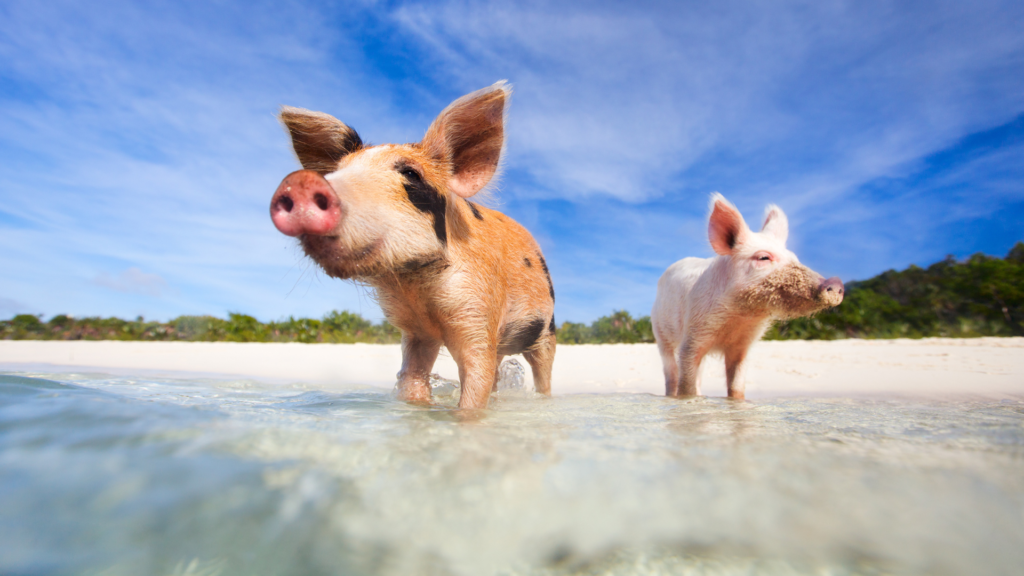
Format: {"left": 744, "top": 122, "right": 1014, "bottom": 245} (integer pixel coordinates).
{"left": 270, "top": 81, "right": 555, "bottom": 409}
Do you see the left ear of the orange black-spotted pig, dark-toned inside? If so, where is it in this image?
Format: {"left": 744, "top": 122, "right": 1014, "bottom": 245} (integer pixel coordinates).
{"left": 280, "top": 106, "right": 362, "bottom": 174}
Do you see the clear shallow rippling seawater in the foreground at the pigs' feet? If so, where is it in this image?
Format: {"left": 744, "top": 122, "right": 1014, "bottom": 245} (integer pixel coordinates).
{"left": 0, "top": 366, "right": 1024, "bottom": 576}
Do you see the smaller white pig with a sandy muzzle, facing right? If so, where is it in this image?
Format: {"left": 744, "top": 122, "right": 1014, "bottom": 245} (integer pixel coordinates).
{"left": 651, "top": 193, "right": 843, "bottom": 400}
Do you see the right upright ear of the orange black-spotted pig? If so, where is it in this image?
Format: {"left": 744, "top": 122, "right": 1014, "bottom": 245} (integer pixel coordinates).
{"left": 421, "top": 80, "right": 512, "bottom": 198}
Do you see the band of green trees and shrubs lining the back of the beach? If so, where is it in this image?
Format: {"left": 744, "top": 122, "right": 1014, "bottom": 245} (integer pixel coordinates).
{"left": 0, "top": 242, "right": 1024, "bottom": 344}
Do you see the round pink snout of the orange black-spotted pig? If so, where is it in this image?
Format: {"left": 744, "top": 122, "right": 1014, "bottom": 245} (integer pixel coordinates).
{"left": 270, "top": 170, "right": 341, "bottom": 236}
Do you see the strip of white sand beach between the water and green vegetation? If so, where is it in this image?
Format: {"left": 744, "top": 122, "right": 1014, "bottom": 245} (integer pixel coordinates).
{"left": 0, "top": 338, "right": 1024, "bottom": 398}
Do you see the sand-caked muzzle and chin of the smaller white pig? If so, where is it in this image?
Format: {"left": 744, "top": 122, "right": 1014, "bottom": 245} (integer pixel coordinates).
{"left": 735, "top": 265, "right": 834, "bottom": 319}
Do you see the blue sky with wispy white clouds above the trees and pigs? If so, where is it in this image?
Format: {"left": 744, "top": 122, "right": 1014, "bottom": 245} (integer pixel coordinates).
{"left": 0, "top": 0, "right": 1024, "bottom": 322}
